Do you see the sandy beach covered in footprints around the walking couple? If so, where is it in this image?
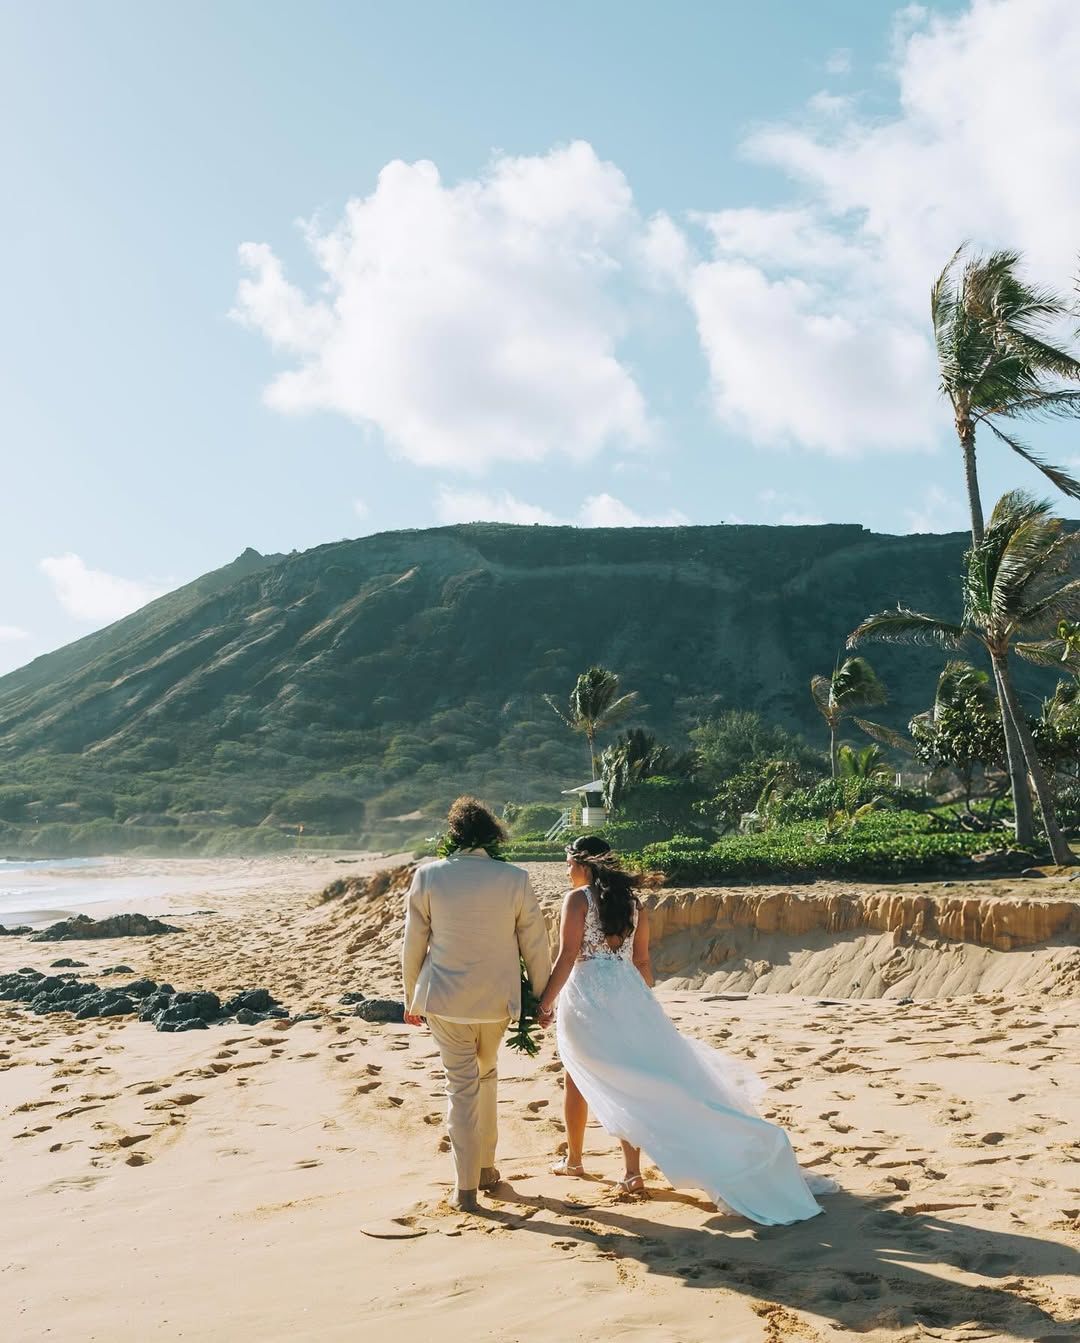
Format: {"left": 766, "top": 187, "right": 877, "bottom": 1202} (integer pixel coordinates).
{"left": 0, "top": 855, "right": 1080, "bottom": 1343}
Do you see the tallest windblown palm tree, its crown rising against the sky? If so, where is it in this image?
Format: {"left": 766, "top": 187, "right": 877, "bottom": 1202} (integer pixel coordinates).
{"left": 930, "top": 246, "right": 1080, "bottom": 843}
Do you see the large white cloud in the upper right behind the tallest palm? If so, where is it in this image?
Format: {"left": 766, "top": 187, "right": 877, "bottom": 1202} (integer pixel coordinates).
{"left": 679, "top": 0, "right": 1080, "bottom": 455}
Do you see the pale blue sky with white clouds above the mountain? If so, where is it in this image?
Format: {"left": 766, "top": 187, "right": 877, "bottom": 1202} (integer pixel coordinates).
{"left": 0, "top": 0, "right": 1080, "bottom": 673}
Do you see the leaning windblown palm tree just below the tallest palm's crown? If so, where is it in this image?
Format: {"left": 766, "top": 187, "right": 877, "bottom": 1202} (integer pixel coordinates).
{"left": 848, "top": 490, "right": 1080, "bottom": 866}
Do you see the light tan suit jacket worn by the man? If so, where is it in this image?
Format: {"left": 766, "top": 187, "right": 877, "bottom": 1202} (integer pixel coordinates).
{"left": 402, "top": 849, "right": 551, "bottom": 1021}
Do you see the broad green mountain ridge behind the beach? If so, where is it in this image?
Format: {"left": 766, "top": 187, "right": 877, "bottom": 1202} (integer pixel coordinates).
{"left": 0, "top": 524, "right": 1031, "bottom": 847}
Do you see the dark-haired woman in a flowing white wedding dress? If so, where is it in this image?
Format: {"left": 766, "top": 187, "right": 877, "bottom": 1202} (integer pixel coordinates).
{"left": 540, "top": 835, "right": 834, "bottom": 1226}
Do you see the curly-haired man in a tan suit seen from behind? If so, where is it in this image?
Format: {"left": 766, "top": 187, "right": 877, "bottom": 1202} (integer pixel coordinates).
{"left": 402, "top": 798, "right": 551, "bottom": 1211}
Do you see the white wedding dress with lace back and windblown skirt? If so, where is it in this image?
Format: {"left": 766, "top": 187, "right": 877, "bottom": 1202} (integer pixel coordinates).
{"left": 556, "top": 889, "right": 836, "bottom": 1226}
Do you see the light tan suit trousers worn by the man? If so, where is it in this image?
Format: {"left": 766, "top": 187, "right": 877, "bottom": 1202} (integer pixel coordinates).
{"left": 427, "top": 1017, "right": 510, "bottom": 1189}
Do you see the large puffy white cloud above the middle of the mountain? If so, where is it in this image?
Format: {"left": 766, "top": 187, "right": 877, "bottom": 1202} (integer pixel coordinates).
{"left": 232, "top": 141, "right": 649, "bottom": 471}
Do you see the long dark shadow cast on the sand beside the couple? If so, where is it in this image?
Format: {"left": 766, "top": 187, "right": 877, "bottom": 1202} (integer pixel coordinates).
{"left": 481, "top": 1180, "right": 1080, "bottom": 1343}
